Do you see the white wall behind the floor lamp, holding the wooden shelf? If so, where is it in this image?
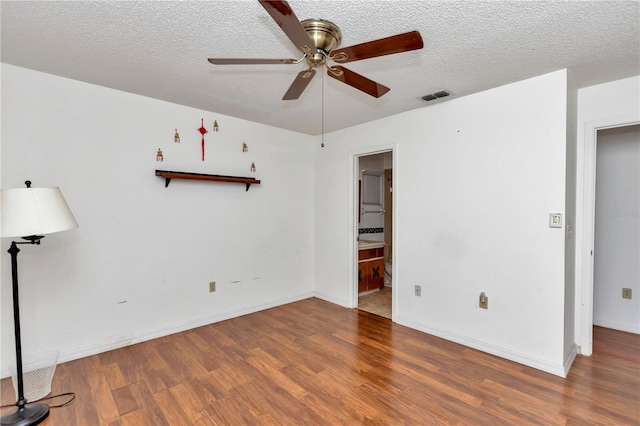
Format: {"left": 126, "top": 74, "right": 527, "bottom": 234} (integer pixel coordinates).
{"left": 1, "top": 64, "right": 314, "bottom": 375}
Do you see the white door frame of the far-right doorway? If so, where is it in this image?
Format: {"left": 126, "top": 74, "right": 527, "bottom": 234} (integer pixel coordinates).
{"left": 576, "top": 115, "right": 640, "bottom": 356}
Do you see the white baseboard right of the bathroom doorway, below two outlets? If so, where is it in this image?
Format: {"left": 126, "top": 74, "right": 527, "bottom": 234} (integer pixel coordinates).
{"left": 394, "top": 316, "right": 575, "bottom": 377}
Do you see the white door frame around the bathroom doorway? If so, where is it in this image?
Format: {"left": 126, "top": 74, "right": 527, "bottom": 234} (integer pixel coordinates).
{"left": 348, "top": 142, "right": 398, "bottom": 321}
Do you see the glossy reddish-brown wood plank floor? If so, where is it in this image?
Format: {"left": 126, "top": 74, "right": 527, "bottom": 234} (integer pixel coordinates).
{"left": 1, "top": 299, "right": 640, "bottom": 426}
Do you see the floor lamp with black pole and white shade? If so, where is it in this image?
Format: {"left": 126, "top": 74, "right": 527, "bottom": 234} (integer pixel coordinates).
{"left": 0, "top": 181, "right": 78, "bottom": 426}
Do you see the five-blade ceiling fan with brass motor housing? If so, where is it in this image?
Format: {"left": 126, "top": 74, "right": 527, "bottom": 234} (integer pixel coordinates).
{"left": 209, "top": 0, "right": 424, "bottom": 100}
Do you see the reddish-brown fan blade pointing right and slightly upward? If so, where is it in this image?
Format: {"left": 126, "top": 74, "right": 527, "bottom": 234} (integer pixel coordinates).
{"left": 330, "top": 31, "right": 424, "bottom": 63}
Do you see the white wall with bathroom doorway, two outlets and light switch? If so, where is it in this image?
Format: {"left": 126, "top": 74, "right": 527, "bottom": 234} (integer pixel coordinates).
{"left": 315, "top": 71, "right": 567, "bottom": 375}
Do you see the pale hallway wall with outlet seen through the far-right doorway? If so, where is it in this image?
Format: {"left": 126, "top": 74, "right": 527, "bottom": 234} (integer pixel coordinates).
{"left": 593, "top": 125, "right": 640, "bottom": 333}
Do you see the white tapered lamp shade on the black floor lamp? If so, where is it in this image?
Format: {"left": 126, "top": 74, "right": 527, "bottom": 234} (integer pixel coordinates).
{"left": 0, "top": 188, "right": 78, "bottom": 238}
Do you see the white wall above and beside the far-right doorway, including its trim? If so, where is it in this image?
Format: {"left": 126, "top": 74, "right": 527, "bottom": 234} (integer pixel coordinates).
{"left": 575, "top": 76, "right": 640, "bottom": 355}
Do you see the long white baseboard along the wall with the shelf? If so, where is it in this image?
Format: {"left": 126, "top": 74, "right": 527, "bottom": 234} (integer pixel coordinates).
{"left": 0, "top": 292, "right": 314, "bottom": 378}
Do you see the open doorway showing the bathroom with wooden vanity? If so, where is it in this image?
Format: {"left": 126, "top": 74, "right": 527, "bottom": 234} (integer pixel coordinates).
{"left": 356, "top": 151, "right": 393, "bottom": 319}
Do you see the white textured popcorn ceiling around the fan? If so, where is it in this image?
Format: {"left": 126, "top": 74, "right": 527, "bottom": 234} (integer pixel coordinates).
{"left": 0, "top": 0, "right": 640, "bottom": 134}
